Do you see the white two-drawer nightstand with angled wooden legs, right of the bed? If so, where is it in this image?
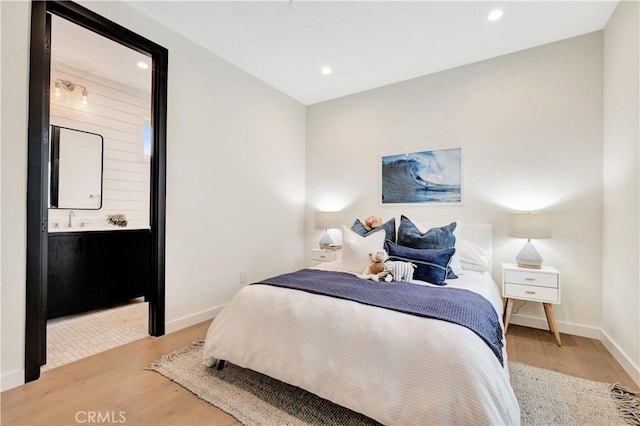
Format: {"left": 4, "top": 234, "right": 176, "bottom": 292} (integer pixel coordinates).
{"left": 502, "top": 263, "right": 562, "bottom": 346}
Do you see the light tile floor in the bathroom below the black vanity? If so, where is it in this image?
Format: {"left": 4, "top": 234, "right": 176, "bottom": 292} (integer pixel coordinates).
{"left": 42, "top": 299, "right": 149, "bottom": 371}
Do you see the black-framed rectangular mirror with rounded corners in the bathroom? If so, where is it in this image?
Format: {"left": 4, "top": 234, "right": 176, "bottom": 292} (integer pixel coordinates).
{"left": 49, "top": 126, "right": 104, "bottom": 210}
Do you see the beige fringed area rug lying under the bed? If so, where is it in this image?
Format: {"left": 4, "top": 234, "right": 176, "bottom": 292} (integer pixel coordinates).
{"left": 149, "top": 341, "right": 640, "bottom": 426}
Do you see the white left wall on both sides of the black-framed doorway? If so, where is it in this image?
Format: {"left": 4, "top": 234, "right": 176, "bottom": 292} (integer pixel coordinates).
{"left": 1, "top": 2, "right": 305, "bottom": 389}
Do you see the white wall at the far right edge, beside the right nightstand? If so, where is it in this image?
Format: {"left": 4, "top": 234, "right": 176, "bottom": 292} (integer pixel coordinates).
{"left": 602, "top": 1, "right": 640, "bottom": 383}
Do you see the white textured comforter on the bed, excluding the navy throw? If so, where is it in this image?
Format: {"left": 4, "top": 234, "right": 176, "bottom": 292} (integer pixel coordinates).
{"left": 203, "top": 265, "right": 520, "bottom": 426}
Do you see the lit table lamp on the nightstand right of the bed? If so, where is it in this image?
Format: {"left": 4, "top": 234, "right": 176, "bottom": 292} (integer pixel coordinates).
{"left": 508, "top": 213, "right": 551, "bottom": 269}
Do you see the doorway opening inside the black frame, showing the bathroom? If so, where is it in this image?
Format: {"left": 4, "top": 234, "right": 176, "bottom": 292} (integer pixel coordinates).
{"left": 42, "top": 15, "right": 153, "bottom": 371}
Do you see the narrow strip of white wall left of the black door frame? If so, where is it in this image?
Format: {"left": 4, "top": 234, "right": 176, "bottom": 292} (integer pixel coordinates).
{"left": 0, "top": 2, "right": 31, "bottom": 390}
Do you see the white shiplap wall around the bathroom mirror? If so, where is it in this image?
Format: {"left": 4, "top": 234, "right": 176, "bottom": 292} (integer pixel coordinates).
{"left": 49, "top": 63, "right": 151, "bottom": 229}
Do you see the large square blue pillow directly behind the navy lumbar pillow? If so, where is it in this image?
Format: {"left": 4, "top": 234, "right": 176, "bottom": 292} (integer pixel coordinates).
{"left": 398, "top": 215, "right": 458, "bottom": 279}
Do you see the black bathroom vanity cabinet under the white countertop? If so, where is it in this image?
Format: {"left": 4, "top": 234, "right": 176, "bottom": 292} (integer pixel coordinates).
{"left": 47, "top": 229, "right": 151, "bottom": 319}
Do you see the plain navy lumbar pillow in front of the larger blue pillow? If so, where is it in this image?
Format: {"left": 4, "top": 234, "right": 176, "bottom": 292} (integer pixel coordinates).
{"left": 385, "top": 241, "right": 456, "bottom": 285}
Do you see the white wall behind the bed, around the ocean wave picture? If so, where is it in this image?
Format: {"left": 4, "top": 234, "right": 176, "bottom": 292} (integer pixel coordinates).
{"left": 306, "top": 32, "right": 602, "bottom": 337}
